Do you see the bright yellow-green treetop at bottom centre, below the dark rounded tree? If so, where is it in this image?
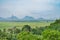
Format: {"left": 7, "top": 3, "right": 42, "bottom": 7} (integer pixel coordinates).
{"left": 17, "top": 31, "right": 41, "bottom": 40}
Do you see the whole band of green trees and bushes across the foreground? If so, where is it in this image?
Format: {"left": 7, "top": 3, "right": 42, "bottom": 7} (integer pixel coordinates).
{"left": 0, "top": 20, "right": 60, "bottom": 40}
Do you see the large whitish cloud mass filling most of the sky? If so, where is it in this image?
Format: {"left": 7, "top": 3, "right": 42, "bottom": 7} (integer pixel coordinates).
{"left": 0, "top": 0, "right": 59, "bottom": 17}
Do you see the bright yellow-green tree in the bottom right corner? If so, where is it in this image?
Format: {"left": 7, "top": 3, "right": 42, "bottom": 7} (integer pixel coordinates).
{"left": 42, "top": 30, "right": 60, "bottom": 40}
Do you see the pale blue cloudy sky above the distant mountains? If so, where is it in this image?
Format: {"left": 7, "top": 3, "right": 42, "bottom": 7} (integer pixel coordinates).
{"left": 0, "top": 0, "right": 60, "bottom": 19}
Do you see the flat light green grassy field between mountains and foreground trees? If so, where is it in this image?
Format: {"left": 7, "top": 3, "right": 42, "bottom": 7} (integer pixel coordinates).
{"left": 0, "top": 22, "right": 51, "bottom": 29}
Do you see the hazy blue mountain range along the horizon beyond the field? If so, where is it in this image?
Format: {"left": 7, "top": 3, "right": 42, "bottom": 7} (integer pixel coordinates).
{"left": 0, "top": 16, "right": 54, "bottom": 21}
